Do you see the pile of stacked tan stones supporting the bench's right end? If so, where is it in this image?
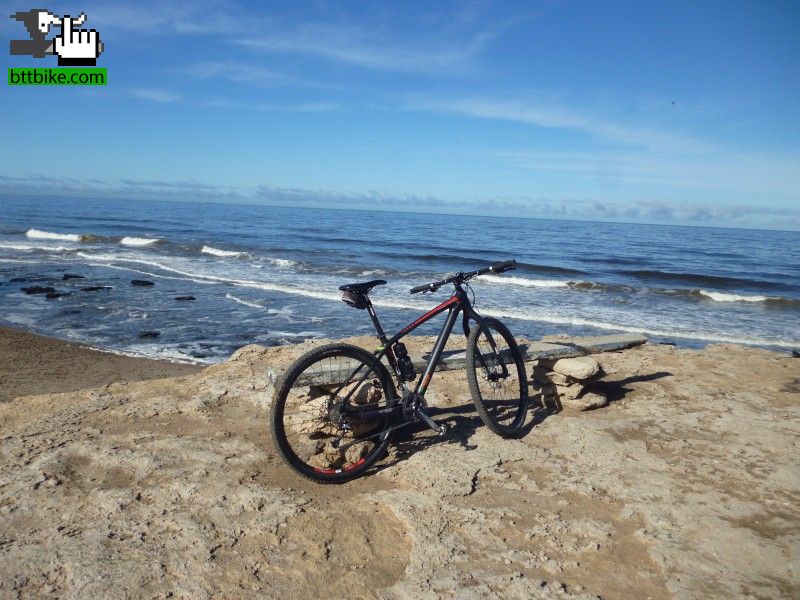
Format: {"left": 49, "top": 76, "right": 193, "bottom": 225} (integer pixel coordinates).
{"left": 533, "top": 356, "right": 608, "bottom": 410}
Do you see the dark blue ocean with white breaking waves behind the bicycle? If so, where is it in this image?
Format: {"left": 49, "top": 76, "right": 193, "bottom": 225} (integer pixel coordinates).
{"left": 0, "top": 197, "right": 800, "bottom": 362}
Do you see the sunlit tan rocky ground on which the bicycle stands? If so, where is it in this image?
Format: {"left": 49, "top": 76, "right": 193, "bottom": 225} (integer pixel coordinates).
{"left": 0, "top": 330, "right": 800, "bottom": 598}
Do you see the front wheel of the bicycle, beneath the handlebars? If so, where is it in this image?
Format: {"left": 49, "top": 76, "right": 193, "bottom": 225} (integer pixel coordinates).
{"left": 466, "top": 318, "right": 528, "bottom": 438}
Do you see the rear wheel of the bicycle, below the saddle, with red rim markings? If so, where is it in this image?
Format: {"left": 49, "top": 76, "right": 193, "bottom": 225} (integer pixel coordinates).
{"left": 271, "top": 344, "right": 396, "bottom": 483}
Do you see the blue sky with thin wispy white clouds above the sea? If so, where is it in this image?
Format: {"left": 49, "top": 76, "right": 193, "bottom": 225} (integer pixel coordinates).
{"left": 0, "top": 0, "right": 800, "bottom": 229}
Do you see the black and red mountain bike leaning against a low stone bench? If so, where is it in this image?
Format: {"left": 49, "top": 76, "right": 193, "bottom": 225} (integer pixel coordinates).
{"left": 271, "top": 260, "right": 528, "bottom": 483}
